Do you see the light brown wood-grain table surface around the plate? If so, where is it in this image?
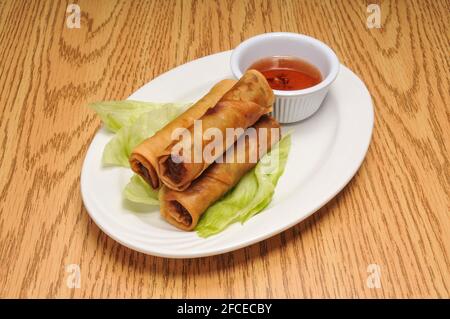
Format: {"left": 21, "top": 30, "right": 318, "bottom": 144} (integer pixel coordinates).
{"left": 0, "top": 0, "right": 450, "bottom": 298}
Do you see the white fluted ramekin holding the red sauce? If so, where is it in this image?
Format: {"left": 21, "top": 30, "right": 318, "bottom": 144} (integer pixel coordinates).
{"left": 231, "top": 32, "right": 340, "bottom": 123}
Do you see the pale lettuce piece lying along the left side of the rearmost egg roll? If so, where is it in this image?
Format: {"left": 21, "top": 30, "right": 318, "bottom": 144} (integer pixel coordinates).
{"left": 102, "top": 103, "right": 189, "bottom": 167}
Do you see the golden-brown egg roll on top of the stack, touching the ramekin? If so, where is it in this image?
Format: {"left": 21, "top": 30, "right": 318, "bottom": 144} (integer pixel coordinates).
{"left": 159, "top": 70, "right": 274, "bottom": 191}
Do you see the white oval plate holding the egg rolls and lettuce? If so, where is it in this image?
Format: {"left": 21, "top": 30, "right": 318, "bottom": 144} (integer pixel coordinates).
{"left": 81, "top": 51, "right": 373, "bottom": 258}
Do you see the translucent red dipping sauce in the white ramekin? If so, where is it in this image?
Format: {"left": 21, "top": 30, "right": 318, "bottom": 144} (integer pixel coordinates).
{"left": 249, "top": 56, "right": 322, "bottom": 91}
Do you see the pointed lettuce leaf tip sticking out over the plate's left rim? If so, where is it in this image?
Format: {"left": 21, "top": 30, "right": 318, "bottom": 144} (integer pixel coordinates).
{"left": 89, "top": 100, "right": 187, "bottom": 132}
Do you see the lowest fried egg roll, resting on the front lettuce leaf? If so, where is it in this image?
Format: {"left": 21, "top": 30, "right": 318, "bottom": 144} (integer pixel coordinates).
{"left": 159, "top": 115, "right": 281, "bottom": 231}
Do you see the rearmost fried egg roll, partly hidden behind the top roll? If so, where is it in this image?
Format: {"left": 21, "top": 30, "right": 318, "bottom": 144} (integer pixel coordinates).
{"left": 130, "top": 80, "right": 237, "bottom": 188}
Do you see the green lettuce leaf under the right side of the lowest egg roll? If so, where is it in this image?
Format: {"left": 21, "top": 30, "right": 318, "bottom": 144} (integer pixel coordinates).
{"left": 196, "top": 135, "right": 291, "bottom": 237}
